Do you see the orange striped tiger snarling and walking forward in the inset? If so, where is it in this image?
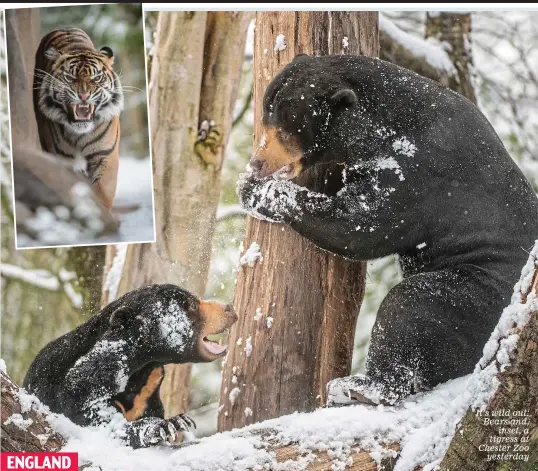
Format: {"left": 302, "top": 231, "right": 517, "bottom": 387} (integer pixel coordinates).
{"left": 33, "top": 28, "right": 124, "bottom": 211}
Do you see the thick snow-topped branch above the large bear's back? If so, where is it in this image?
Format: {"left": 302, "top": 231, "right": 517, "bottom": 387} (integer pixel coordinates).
{"left": 379, "top": 14, "right": 456, "bottom": 85}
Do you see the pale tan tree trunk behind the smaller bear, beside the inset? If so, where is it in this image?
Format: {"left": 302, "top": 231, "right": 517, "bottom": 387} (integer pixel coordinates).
{"left": 102, "top": 12, "right": 250, "bottom": 416}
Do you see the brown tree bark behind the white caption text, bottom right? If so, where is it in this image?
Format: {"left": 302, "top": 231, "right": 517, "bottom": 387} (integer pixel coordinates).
{"left": 441, "top": 272, "right": 538, "bottom": 471}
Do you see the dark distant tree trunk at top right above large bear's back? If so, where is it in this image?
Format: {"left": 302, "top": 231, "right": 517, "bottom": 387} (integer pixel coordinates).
{"left": 426, "top": 12, "right": 476, "bottom": 105}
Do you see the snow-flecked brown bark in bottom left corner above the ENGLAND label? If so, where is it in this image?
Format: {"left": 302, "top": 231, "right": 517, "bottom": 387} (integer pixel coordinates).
{"left": 0, "top": 371, "right": 64, "bottom": 452}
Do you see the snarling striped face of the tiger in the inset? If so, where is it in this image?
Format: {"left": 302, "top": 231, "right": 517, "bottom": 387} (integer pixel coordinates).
{"left": 36, "top": 47, "right": 123, "bottom": 134}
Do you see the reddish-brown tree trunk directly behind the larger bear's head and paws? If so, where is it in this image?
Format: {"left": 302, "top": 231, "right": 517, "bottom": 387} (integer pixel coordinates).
{"left": 218, "top": 12, "right": 378, "bottom": 431}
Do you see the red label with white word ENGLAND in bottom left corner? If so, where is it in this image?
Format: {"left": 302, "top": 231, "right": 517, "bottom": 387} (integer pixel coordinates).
{"left": 0, "top": 452, "right": 78, "bottom": 471}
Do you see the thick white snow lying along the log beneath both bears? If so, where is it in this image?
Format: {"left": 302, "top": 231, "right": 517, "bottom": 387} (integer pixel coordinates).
{"left": 0, "top": 245, "right": 538, "bottom": 471}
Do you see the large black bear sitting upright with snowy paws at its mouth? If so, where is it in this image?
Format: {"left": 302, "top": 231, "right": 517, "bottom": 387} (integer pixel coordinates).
{"left": 238, "top": 55, "right": 538, "bottom": 404}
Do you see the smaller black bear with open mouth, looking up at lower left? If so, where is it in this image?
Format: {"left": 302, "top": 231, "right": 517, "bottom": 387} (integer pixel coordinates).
{"left": 23, "top": 284, "right": 237, "bottom": 448}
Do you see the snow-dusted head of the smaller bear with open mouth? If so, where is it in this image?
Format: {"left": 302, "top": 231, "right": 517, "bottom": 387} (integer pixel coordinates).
{"left": 102, "top": 284, "right": 237, "bottom": 364}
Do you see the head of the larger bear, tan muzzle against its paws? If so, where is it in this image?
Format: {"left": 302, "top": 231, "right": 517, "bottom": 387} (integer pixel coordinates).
{"left": 249, "top": 54, "right": 357, "bottom": 180}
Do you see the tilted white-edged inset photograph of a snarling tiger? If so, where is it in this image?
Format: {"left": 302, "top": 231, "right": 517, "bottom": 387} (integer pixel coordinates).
{"left": 6, "top": 3, "right": 155, "bottom": 249}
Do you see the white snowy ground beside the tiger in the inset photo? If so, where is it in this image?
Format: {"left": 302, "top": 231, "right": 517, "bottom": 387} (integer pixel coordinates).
{"left": 99, "top": 157, "right": 155, "bottom": 243}
